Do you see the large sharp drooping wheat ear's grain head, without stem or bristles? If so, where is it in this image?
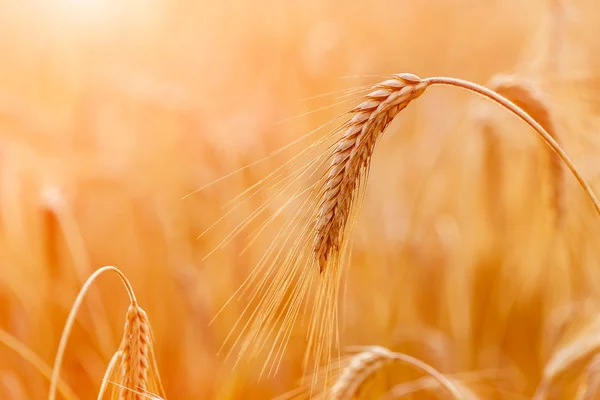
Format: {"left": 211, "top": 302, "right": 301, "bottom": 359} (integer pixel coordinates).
{"left": 314, "top": 74, "right": 429, "bottom": 272}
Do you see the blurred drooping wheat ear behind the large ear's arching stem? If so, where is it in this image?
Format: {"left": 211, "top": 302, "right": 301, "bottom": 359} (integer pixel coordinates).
{"left": 489, "top": 74, "right": 566, "bottom": 225}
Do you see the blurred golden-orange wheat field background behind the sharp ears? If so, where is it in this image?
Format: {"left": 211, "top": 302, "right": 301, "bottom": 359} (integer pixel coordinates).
{"left": 0, "top": 0, "right": 600, "bottom": 400}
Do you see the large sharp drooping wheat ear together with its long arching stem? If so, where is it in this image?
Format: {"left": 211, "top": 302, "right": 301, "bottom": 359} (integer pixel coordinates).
{"left": 313, "top": 74, "right": 600, "bottom": 272}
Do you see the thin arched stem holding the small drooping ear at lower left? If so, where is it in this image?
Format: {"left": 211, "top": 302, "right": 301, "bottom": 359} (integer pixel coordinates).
{"left": 48, "top": 265, "right": 137, "bottom": 400}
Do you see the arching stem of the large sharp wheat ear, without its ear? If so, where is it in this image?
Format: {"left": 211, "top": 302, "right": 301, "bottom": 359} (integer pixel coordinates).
{"left": 423, "top": 77, "right": 600, "bottom": 219}
